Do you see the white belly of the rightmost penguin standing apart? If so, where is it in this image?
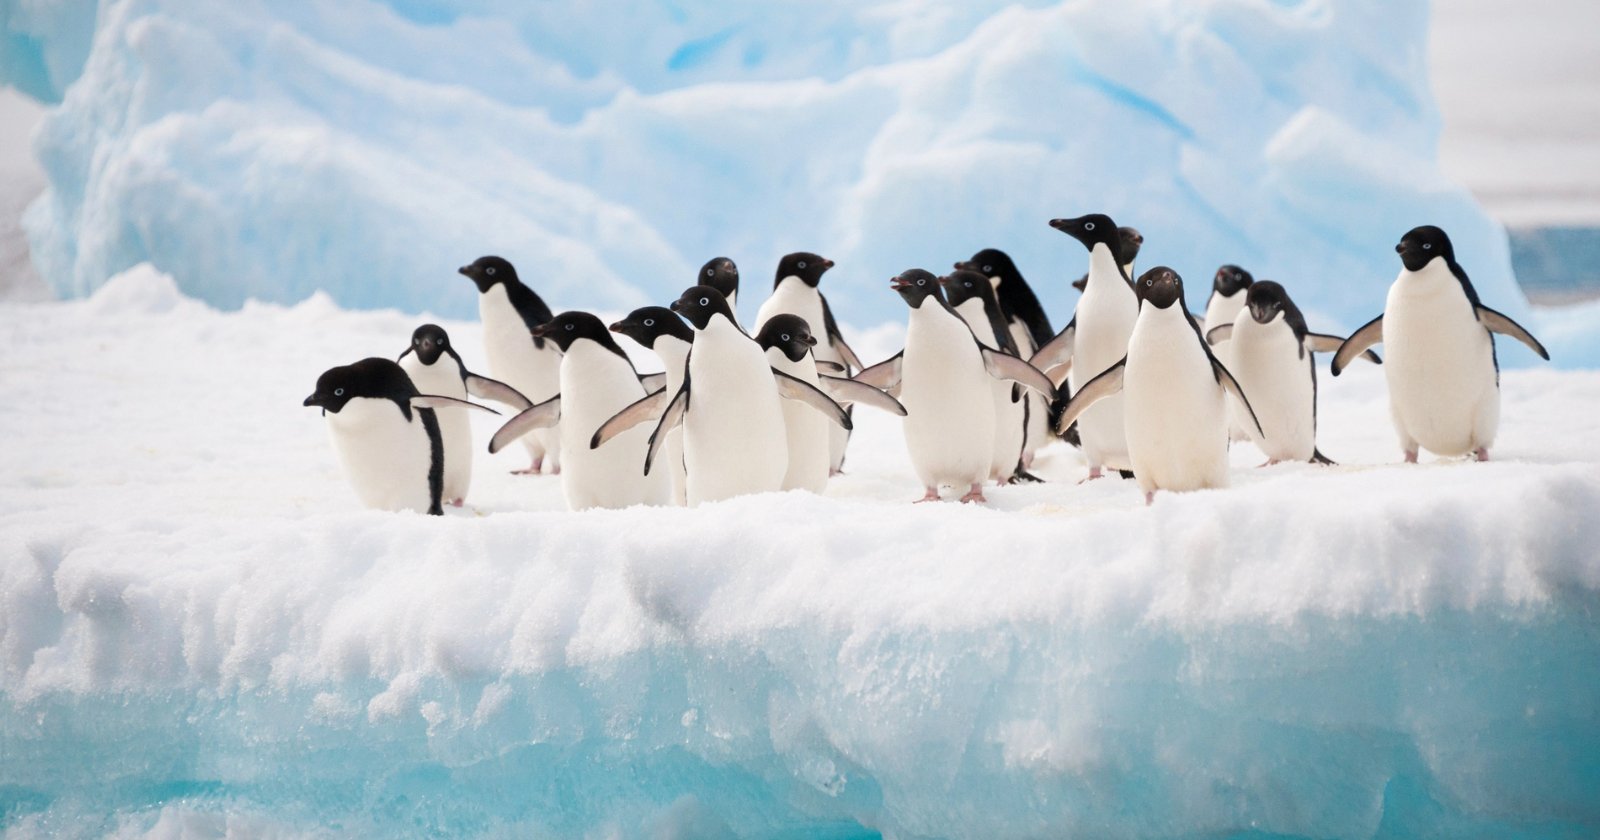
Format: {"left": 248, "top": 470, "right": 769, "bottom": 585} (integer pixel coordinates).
{"left": 1384, "top": 259, "right": 1499, "bottom": 456}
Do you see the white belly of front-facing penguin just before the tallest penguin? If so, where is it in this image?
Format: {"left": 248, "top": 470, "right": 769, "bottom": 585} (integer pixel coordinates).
{"left": 1123, "top": 304, "right": 1227, "bottom": 493}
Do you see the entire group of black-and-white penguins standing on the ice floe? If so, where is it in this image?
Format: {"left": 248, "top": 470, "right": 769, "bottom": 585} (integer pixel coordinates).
{"left": 304, "top": 214, "right": 1549, "bottom": 514}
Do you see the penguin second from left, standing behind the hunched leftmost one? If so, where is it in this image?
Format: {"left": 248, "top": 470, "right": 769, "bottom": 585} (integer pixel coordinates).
{"left": 398, "top": 323, "right": 533, "bottom": 507}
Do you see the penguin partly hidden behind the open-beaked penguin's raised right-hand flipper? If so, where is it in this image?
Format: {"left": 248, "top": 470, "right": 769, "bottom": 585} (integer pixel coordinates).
{"left": 939, "top": 269, "right": 1040, "bottom": 485}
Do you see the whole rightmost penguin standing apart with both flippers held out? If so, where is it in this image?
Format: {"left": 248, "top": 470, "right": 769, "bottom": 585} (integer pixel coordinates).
{"left": 1333, "top": 224, "right": 1550, "bottom": 464}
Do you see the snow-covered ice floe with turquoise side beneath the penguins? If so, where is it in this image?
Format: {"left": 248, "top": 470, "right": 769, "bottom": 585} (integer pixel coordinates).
{"left": 0, "top": 269, "right": 1600, "bottom": 837}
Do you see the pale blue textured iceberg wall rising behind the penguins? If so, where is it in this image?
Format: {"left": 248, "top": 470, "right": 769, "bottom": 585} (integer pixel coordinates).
{"left": 0, "top": 0, "right": 1548, "bottom": 358}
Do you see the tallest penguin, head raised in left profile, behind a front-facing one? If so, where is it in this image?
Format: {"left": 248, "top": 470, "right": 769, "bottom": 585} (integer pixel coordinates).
{"left": 1032, "top": 213, "right": 1139, "bottom": 480}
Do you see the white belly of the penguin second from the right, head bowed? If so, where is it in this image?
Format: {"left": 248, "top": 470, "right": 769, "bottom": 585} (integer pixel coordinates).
{"left": 1222, "top": 315, "right": 1317, "bottom": 461}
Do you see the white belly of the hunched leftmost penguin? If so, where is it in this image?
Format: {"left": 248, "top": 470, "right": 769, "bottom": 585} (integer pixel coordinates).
{"left": 328, "top": 397, "right": 434, "bottom": 514}
